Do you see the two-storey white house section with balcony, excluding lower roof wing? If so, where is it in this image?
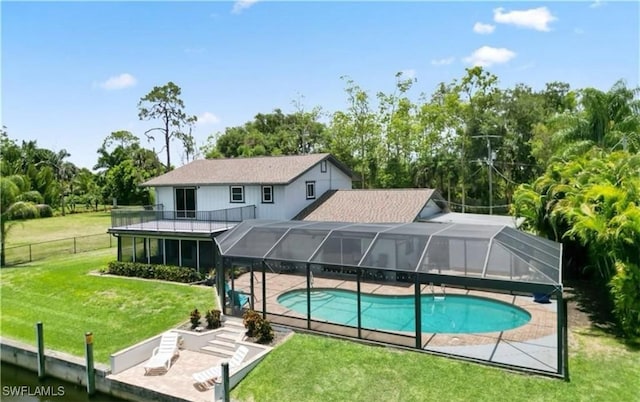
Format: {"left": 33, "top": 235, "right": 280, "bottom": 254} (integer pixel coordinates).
{"left": 108, "top": 153, "right": 353, "bottom": 272}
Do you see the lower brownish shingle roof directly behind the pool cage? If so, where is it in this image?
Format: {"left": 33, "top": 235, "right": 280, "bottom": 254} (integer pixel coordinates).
{"left": 296, "top": 189, "right": 434, "bottom": 223}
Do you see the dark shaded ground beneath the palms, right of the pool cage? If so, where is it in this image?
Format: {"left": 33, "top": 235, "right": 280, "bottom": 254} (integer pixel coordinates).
{"left": 564, "top": 279, "right": 640, "bottom": 351}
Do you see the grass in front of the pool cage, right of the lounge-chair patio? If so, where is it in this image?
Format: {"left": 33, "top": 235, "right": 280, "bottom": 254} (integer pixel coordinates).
{"left": 231, "top": 330, "right": 640, "bottom": 402}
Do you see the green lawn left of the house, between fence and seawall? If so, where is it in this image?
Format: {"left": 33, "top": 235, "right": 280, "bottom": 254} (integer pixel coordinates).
{"left": 0, "top": 249, "right": 216, "bottom": 363}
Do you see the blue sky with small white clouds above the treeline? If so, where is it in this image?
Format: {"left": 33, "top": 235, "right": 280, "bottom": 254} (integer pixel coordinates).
{"left": 0, "top": 1, "right": 640, "bottom": 168}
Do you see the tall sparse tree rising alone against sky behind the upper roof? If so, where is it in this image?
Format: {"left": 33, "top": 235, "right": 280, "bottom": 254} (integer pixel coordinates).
{"left": 138, "top": 81, "right": 198, "bottom": 172}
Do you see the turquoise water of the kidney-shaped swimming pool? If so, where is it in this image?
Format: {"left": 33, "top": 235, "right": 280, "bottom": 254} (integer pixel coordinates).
{"left": 278, "top": 289, "right": 531, "bottom": 334}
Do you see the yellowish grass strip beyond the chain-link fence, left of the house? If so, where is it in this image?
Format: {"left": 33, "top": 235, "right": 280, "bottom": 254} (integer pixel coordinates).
{"left": 7, "top": 212, "right": 111, "bottom": 247}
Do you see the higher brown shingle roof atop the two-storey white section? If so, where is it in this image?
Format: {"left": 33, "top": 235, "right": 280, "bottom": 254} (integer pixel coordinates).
{"left": 142, "top": 153, "right": 352, "bottom": 187}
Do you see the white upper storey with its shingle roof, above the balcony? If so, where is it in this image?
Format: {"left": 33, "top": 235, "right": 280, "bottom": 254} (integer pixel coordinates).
{"left": 149, "top": 154, "right": 352, "bottom": 219}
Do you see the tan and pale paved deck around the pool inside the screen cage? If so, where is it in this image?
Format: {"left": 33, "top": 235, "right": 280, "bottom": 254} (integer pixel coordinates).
{"left": 235, "top": 272, "right": 558, "bottom": 373}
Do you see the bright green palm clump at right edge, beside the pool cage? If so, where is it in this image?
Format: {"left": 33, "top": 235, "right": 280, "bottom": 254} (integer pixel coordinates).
{"left": 515, "top": 147, "right": 640, "bottom": 336}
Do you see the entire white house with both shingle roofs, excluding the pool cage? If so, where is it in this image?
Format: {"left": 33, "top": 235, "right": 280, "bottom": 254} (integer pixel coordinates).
{"left": 108, "top": 153, "right": 516, "bottom": 272}
